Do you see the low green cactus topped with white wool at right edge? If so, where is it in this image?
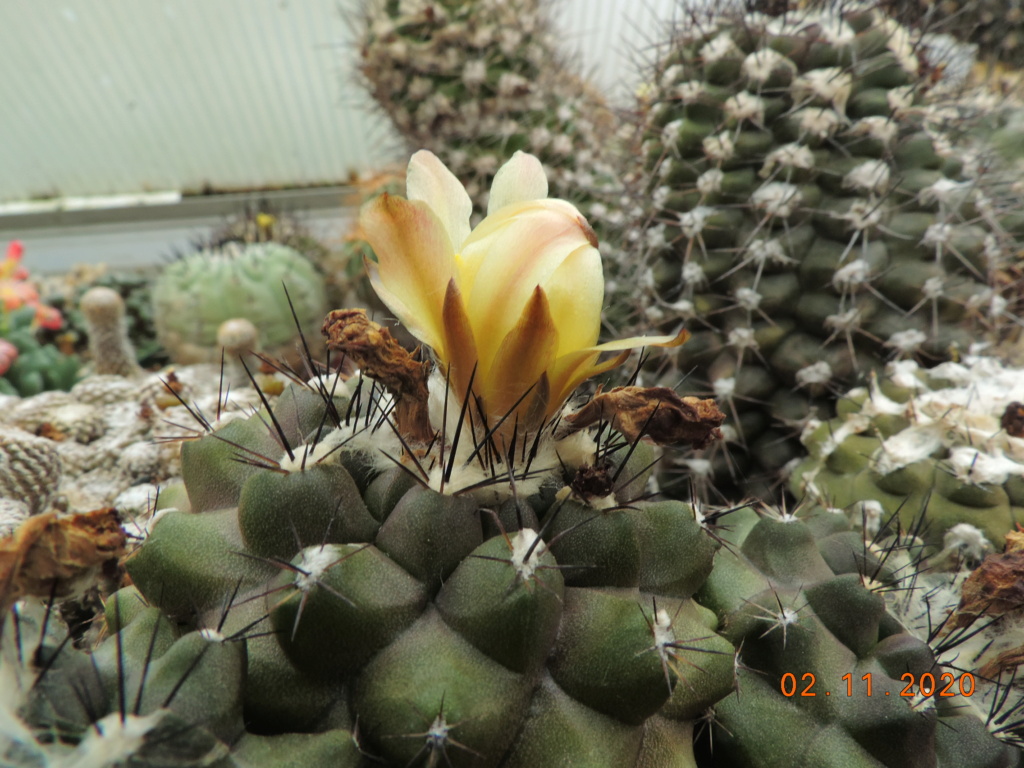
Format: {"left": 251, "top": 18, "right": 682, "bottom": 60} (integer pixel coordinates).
{"left": 791, "top": 357, "right": 1024, "bottom": 564}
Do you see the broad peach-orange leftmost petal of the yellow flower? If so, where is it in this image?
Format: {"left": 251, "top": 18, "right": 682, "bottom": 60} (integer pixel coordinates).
{"left": 359, "top": 195, "right": 455, "bottom": 347}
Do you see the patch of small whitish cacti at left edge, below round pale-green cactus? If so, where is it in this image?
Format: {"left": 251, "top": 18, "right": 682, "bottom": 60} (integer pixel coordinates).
{"left": 0, "top": 352, "right": 283, "bottom": 519}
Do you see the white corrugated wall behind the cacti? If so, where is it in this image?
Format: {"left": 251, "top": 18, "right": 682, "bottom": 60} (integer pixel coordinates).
{"left": 0, "top": 0, "right": 688, "bottom": 202}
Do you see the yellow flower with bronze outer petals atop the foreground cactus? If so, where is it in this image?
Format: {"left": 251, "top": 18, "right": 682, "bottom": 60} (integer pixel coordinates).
{"left": 360, "top": 151, "right": 687, "bottom": 435}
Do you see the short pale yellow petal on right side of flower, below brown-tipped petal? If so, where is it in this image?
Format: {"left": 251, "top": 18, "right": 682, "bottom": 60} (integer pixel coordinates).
{"left": 544, "top": 243, "right": 604, "bottom": 355}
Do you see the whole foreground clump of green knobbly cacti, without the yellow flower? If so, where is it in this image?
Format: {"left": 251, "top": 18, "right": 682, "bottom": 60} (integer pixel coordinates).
{"left": 0, "top": 379, "right": 1021, "bottom": 768}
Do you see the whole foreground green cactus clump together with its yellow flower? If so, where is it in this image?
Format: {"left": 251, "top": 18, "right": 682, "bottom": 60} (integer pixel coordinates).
{"left": 0, "top": 147, "right": 1020, "bottom": 768}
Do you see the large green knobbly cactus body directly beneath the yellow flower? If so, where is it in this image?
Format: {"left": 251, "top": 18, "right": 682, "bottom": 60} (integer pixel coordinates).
{"left": 0, "top": 370, "right": 733, "bottom": 768}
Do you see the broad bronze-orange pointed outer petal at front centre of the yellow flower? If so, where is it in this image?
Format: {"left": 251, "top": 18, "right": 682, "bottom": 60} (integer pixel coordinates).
{"left": 479, "top": 287, "right": 558, "bottom": 429}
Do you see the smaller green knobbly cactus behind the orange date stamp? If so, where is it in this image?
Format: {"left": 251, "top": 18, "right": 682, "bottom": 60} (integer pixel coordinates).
{"left": 697, "top": 505, "right": 1022, "bottom": 768}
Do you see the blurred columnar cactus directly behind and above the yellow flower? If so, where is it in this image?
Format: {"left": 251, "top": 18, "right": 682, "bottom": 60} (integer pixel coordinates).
{"left": 359, "top": 0, "right": 624, "bottom": 240}
